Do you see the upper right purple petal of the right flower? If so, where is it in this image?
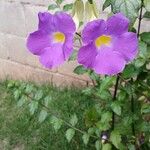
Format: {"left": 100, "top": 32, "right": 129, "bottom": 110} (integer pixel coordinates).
{"left": 107, "top": 13, "right": 129, "bottom": 35}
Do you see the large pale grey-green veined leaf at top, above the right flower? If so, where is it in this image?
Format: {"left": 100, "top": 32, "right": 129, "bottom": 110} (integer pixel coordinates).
{"left": 111, "top": 0, "right": 141, "bottom": 25}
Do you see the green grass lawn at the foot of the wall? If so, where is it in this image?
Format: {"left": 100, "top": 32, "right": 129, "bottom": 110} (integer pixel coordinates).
{"left": 0, "top": 81, "right": 95, "bottom": 150}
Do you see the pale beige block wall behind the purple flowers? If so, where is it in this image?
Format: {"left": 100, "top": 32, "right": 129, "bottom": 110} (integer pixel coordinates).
{"left": 0, "top": 0, "right": 149, "bottom": 86}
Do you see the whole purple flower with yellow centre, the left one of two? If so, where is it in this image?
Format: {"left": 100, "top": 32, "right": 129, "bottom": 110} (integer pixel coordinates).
{"left": 27, "top": 12, "right": 76, "bottom": 68}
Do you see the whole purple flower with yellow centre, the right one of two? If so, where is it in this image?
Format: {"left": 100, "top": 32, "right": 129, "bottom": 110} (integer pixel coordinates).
{"left": 78, "top": 13, "right": 138, "bottom": 75}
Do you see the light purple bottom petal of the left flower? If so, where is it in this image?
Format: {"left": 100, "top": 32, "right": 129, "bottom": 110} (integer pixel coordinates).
{"left": 40, "top": 44, "right": 65, "bottom": 69}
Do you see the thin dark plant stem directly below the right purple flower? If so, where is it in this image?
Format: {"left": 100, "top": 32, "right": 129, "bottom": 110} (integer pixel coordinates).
{"left": 112, "top": 75, "right": 120, "bottom": 130}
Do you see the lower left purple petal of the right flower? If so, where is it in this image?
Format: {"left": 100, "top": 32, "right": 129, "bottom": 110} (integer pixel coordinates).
{"left": 78, "top": 43, "right": 97, "bottom": 68}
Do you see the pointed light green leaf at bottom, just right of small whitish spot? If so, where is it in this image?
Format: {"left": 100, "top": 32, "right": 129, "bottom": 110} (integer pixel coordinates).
{"left": 110, "top": 131, "right": 121, "bottom": 149}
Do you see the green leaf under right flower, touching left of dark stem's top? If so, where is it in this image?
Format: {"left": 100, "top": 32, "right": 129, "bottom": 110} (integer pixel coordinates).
{"left": 99, "top": 77, "right": 115, "bottom": 93}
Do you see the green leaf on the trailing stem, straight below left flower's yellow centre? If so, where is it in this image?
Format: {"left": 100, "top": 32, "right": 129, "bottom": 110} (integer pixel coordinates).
{"left": 51, "top": 116, "right": 63, "bottom": 132}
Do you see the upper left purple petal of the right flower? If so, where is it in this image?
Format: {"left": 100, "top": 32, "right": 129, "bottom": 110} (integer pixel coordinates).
{"left": 82, "top": 20, "right": 107, "bottom": 44}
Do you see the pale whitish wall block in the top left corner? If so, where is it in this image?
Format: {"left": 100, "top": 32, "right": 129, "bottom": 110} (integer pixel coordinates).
{"left": 0, "top": 1, "right": 26, "bottom": 36}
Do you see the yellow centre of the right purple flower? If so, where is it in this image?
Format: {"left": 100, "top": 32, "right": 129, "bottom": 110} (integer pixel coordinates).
{"left": 95, "top": 35, "right": 111, "bottom": 48}
